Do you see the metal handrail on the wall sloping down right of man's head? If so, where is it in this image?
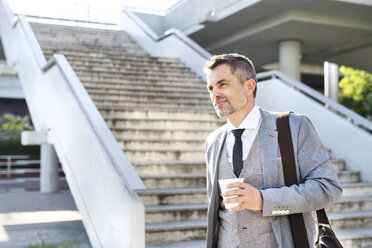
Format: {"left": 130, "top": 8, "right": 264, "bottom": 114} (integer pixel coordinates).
{"left": 257, "top": 70, "right": 372, "bottom": 132}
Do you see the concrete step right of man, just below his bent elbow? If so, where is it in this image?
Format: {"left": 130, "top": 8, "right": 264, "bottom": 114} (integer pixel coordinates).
{"left": 327, "top": 195, "right": 372, "bottom": 212}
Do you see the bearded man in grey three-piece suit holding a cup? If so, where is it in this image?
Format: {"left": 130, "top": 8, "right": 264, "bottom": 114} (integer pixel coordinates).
{"left": 204, "top": 54, "right": 342, "bottom": 248}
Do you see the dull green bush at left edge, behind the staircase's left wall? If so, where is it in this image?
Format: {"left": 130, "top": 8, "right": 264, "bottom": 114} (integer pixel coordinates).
{"left": 0, "top": 114, "right": 32, "bottom": 139}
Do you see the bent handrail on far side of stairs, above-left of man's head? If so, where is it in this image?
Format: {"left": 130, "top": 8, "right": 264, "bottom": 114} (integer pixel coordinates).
{"left": 123, "top": 8, "right": 212, "bottom": 60}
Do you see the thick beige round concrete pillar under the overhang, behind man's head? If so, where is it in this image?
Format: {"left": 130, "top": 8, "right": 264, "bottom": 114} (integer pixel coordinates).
{"left": 279, "top": 40, "right": 301, "bottom": 81}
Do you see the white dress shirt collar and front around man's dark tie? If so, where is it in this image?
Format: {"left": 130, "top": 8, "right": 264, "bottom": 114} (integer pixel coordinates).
{"left": 226, "top": 105, "right": 262, "bottom": 168}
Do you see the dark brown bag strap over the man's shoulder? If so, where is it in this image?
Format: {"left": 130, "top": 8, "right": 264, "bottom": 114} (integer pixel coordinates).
{"left": 276, "top": 112, "right": 310, "bottom": 248}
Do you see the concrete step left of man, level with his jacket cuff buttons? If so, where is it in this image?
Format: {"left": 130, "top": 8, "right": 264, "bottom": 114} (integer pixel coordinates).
{"left": 146, "top": 204, "right": 208, "bottom": 223}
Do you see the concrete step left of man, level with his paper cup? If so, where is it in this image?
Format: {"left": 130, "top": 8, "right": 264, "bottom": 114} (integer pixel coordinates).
{"left": 138, "top": 188, "right": 208, "bottom": 206}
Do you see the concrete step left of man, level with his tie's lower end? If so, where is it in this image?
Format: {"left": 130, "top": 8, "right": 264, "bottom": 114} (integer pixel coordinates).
{"left": 131, "top": 160, "right": 206, "bottom": 175}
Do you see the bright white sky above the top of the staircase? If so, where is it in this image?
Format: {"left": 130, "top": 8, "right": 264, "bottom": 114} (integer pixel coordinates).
{"left": 8, "top": 0, "right": 179, "bottom": 23}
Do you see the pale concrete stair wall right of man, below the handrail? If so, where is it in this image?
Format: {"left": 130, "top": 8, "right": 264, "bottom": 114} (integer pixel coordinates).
{"left": 256, "top": 79, "right": 372, "bottom": 182}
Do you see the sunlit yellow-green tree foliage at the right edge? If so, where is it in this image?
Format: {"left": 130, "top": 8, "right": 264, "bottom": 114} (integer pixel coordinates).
{"left": 338, "top": 66, "right": 372, "bottom": 119}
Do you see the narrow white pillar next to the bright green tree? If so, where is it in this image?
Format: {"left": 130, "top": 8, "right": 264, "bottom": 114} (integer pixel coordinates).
{"left": 324, "top": 61, "right": 338, "bottom": 102}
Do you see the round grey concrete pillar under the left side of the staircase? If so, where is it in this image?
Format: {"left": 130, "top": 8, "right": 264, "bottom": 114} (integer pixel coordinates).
{"left": 40, "top": 145, "right": 58, "bottom": 193}
